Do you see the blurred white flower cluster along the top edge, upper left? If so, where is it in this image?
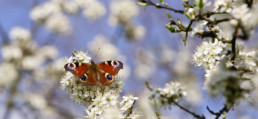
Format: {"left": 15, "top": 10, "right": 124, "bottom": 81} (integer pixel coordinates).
{"left": 30, "top": 0, "right": 106, "bottom": 34}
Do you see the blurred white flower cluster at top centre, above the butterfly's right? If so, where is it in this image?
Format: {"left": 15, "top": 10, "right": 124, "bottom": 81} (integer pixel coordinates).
{"left": 109, "top": 0, "right": 145, "bottom": 40}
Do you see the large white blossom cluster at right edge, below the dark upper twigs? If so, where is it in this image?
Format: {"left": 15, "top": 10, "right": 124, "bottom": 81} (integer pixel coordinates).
{"left": 193, "top": 38, "right": 257, "bottom": 104}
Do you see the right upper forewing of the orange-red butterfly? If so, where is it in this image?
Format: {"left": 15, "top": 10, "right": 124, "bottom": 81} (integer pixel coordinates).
{"left": 97, "top": 60, "right": 123, "bottom": 75}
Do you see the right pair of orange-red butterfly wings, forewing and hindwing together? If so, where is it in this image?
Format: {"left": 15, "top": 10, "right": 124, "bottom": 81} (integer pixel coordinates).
{"left": 96, "top": 61, "right": 123, "bottom": 85}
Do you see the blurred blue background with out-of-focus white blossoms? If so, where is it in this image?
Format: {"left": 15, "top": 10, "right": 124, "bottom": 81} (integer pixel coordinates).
{"left": 0, "top": 0, "right": 258, "bottom": 119}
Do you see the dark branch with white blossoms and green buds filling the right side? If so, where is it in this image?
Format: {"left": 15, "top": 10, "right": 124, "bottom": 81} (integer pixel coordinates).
{"left": 138, "top": 0, "right": 258, "bottom": 118}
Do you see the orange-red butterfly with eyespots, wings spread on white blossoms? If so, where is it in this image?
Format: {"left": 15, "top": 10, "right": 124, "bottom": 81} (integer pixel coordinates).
{"left": 64, "top": 60, "right": 123, "bottom": 86}
